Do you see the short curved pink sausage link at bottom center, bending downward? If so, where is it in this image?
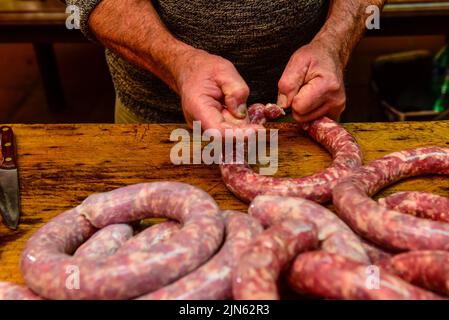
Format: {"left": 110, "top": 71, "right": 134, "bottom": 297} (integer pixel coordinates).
{"left": 232, "top": 220, "right": 318, "bottom": 300}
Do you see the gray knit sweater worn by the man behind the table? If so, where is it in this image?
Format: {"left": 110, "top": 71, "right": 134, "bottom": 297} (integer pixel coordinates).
{"left": 66, "top": 0, "right": 328, "bottom": 122}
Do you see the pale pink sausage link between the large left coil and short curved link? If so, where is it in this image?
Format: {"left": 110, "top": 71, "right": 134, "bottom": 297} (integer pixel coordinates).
{"left": 139, "top": 211, "right": 263, "bottom": 300}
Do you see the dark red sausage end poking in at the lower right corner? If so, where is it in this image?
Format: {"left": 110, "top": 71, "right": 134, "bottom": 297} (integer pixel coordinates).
{"left": 384, "top": 251, "right": 449, "bottom": 295}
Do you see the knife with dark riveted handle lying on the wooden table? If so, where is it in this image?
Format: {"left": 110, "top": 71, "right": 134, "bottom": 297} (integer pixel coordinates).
{"left": 0, "top": 127, "right": 20, "bottom": 229}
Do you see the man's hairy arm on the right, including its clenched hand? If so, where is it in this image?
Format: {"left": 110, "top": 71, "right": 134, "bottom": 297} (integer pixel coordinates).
{"left": 277, "top": 0, "right": 385, "bottom": 122}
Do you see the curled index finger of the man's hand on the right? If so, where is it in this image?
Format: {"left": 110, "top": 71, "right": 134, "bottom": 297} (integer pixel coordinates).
{"left": 292, "top": 78, "right": 327, "bottom": 115}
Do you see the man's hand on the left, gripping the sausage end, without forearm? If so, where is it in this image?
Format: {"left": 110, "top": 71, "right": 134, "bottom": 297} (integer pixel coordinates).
{"left": 175, "top": 48, "right": 259, "bottom": 133}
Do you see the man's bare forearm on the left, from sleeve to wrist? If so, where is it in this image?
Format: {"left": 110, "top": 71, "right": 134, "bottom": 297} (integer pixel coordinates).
{"left": 89, "top": 0, "right": 193, "bottom": 92}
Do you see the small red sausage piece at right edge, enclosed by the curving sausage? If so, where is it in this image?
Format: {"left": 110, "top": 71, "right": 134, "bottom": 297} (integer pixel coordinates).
{"left": 379, "top": 191, "right": 449, "bottom": 222}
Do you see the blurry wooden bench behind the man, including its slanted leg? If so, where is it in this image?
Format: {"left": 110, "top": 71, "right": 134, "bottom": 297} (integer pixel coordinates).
{"left": 0, "top": 0, "right": 449, "bottom": 120}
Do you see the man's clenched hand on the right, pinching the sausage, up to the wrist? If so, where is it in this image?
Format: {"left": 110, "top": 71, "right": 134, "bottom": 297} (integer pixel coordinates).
{"left": 278, "top": 41, "right": 346, "bottom": 122}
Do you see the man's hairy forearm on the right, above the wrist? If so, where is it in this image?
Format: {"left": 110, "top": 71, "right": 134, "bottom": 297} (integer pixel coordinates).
{"left": 314, "top": 0, "right": 386, "bottom": 66}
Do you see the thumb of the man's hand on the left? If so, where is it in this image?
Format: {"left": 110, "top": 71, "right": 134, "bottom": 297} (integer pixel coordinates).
{"left": 217, "top": 70, "right": 249, "bottom": 119}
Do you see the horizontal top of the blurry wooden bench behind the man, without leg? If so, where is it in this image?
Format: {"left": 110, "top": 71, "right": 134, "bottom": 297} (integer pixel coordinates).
{"left": 0, "top": 0, "right": 449, "bottom": 42}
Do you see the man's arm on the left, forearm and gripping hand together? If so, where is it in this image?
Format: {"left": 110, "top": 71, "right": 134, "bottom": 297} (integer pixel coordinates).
{"left": 89, "top": 0, "right": 254, "bottom": 131}
